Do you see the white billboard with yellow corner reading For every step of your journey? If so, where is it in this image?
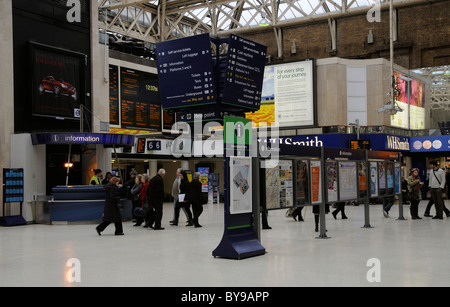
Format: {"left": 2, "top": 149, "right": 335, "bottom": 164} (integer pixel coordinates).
{"left": 246, "top": 61, "right": 315, "bottom": 127}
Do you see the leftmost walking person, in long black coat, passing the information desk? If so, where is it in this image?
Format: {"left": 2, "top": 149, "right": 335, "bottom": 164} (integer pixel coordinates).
{"left": 95, "top": 177, "right": 124, "bottom": 236}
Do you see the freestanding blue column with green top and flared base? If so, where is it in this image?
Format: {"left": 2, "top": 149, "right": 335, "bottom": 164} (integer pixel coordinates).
{"left": 212, "top": 117, "right": 266, "bottom": 259}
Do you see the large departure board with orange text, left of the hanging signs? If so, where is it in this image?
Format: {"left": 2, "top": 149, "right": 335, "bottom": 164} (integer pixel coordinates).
{"left": 120, "top": 68, "right": 161, "bottom": 131}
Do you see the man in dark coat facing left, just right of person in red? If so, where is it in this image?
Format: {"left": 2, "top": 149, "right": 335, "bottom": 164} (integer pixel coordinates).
{"left": 148, "top": 168, "right": 166, "bottom": 230}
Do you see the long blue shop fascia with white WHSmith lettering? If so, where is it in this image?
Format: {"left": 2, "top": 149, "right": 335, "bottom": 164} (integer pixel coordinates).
{"left": 260, "top": 133, "right": 410, "bottom": 151}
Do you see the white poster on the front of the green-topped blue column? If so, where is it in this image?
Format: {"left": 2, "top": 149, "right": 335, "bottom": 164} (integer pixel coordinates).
{"left": 230, "top": 157, "right": 252, "bottom": 214}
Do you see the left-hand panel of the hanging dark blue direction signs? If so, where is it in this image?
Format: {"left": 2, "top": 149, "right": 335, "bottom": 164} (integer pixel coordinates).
{"left": 156, "top": 34, "right": 217, "bottom": 109}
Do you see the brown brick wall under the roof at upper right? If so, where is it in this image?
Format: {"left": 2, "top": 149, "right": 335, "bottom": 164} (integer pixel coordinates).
{"left": 244, "top": 0, "right": 450, "bottom": 69}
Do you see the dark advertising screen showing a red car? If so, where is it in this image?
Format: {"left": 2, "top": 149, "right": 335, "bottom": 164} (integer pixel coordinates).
{"left": 31, "top": 45, "right": 84, "bottom": 119}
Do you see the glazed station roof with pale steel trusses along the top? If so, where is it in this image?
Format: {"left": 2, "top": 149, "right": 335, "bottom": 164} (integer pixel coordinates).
{"left": 97, "top": 0, "right": 426, "bottom": 43}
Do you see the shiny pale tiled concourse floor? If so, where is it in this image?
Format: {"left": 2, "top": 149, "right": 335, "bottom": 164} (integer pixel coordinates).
{"left": 0, "top": 202, "right": 450, "bottom": 287}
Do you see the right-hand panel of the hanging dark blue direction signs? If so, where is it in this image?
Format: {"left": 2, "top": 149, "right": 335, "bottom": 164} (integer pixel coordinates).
{"left": 222, "top": 35, "right": 267, "bottom": 110}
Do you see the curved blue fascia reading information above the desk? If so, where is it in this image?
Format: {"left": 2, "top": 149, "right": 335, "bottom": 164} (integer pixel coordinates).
{"left": 31, "top": 132, "right": 135, "bottom": 146}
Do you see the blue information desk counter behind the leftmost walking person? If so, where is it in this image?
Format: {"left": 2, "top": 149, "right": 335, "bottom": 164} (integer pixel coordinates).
{"left": 49, "top": 185, "right": 132, "bottom": 222}
